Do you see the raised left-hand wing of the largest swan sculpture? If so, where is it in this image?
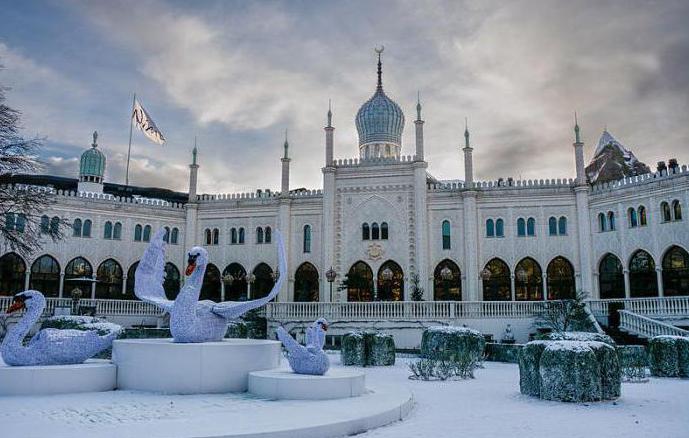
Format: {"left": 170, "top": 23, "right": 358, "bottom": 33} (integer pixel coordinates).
{"left": 134, "top": 228, "right": 174, "bottom": 312}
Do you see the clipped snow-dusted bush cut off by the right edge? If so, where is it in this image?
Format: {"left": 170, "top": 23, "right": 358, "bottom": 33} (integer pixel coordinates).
{"left": 648, "top": 336, "right": 689, "bottom": 377}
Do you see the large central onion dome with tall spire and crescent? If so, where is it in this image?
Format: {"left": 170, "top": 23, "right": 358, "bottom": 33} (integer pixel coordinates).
{"left": 356, "top": 49, "right": 404, "bottom": 158}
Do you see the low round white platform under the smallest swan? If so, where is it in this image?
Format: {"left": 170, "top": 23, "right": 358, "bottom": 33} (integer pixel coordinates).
{"left": 249, "top": 368, "right": 366, "bottom": 400}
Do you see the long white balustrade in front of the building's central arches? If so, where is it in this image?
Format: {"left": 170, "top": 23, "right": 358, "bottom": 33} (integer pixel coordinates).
{"left": 266, "top": 301, "right": 543, "bottom": 321}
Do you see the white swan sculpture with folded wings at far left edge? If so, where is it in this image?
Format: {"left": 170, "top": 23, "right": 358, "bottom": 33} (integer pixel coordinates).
{"left": 0, "top": 290, "right": 120, "bottom": 366}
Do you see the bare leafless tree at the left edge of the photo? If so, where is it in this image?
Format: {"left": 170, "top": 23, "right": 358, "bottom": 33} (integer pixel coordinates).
{"left": 0, "top": 72, "right": 69, "bottom": 255}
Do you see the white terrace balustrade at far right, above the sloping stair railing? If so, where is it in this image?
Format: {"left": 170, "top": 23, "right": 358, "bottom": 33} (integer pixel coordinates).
{"left": 588, "top": 296, "right": 689, "bottom": 318}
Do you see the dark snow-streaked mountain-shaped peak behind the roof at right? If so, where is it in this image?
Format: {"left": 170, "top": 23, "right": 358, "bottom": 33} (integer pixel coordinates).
{"left": 586, "top": 130, "right": 651, "bottom": 183}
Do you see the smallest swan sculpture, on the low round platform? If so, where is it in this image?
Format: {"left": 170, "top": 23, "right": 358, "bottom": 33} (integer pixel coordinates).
{"left": 277, "top": 318, "right": 330, "bottom": 376}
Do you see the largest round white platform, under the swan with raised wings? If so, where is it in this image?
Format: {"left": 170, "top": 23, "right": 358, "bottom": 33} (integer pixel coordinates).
{"left": 112, "top": 339, "right": 281, "bottom": 394}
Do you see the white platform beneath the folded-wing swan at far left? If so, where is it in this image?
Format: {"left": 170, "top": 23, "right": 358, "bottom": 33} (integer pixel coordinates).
{"left": 0, "top": 359, "right": 117, "bottom": 396}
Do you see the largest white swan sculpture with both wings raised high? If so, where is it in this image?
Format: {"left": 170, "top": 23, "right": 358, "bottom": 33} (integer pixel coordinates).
{"left": 134, "top": 229, "right": 287, "bottom": 343}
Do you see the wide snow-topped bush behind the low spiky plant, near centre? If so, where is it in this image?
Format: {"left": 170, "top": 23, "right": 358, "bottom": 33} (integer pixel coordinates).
{"left": 421, "top": 326, "right": 486, "bottom": 364}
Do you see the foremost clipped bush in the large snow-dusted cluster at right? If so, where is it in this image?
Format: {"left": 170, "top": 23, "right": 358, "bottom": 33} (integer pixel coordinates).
{"left": 539, "top": 341, "right": 601, "bottom": 402}
